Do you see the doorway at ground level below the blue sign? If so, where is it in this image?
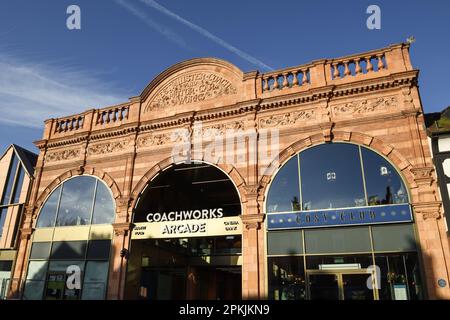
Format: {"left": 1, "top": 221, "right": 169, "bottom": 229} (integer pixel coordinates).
{"left": 307, "top": 270, "right": 377, "bottom": 300}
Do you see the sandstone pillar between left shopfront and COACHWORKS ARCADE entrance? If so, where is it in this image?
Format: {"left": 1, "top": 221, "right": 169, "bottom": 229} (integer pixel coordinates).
{"left": 107, "top": 222, "right": 133, "bottom": 300}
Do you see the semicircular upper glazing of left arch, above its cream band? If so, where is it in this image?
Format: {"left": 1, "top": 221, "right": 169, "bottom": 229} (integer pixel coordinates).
{"left": 36, "top": 176, "right": 114, "bottom": 228}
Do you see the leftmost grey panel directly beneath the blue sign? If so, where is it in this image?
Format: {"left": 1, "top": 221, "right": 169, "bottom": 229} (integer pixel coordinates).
{"left": 267, "top": 230, "right": 303, "bottom": 255}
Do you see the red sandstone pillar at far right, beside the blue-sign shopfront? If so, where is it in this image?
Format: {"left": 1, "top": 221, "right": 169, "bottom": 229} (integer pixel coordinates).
{"left": 411, "top": 167, "right": 450, "bottom": 299}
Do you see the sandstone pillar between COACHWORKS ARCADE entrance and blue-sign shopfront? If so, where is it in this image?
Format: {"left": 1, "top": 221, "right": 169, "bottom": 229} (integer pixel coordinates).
{"left": 241, "top": 192, "right": 265, "bottom": 299}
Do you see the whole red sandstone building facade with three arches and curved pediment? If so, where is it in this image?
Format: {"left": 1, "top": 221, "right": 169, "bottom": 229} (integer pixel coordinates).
{"left": 10, "top": 44, "right": 450, "bottom": 300}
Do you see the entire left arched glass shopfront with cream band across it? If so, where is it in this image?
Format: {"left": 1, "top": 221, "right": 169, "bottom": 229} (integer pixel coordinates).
{"left": 23, "top": 176, "right": 115, "bottom": 300}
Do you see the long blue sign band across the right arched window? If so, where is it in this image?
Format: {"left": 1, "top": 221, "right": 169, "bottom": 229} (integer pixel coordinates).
{"left": 267, "top": 204, "right": 412, "bottom": 230}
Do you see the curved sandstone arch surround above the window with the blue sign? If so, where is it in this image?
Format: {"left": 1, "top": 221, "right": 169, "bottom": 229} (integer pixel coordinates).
{"left": 258, "top": 131, "right": 417, "bottom": 210}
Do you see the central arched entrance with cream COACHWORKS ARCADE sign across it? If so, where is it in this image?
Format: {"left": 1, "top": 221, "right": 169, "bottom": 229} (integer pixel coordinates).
{"left": 125, "top": 163, "right": 242, "bottom": 300}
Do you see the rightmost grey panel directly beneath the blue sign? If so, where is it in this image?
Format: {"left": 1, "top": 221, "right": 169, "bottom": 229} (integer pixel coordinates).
{"left": 372, "top": 224, "right": 416, "bottom": 251}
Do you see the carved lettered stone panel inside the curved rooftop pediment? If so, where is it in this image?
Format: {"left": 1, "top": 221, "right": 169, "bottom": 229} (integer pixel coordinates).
{"left": 144, "top": 71, "right": 237, "bottom": 112}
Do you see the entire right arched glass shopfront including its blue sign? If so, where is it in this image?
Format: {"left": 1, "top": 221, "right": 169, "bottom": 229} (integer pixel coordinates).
{"left": 266, "top": 143, "right": 424, "bottom": 300}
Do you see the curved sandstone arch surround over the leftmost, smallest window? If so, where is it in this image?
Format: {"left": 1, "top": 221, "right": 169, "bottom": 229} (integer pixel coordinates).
{"left": 33, "top": 167, "right": 122, "bottom": 221}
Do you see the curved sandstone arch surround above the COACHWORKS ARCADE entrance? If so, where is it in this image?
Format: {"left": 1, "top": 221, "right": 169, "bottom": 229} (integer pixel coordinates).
{"left": 130, "top": 156, "right": 247, "bottom": 219}
